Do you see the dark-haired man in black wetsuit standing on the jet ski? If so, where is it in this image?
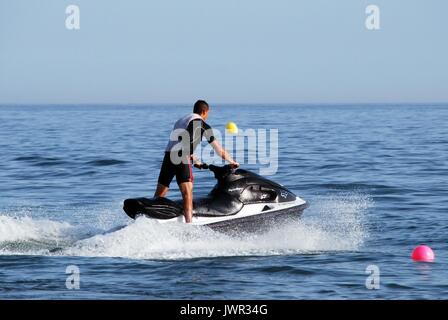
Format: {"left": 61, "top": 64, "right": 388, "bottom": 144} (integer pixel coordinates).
{"left": 154, "top": 100, "right": 239, "bottom": 223}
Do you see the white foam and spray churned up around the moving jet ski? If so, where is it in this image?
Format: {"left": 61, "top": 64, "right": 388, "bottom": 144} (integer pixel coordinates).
{"left": 0, "top": 194, "right": 372, "bottom": 259}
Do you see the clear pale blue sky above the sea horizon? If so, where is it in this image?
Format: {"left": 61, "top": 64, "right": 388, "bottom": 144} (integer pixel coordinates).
{"left": 0, "top": 0, "right": 448, "bottom": 104}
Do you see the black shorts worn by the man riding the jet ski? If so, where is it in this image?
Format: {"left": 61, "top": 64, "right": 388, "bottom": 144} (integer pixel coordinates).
{"left": 158, "top": 152, "right": 194, "bottom": 188}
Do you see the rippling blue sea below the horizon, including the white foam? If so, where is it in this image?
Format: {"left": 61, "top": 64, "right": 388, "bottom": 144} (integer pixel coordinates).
{"left": 0, "top": 104, "right": 448, "bottom": 299}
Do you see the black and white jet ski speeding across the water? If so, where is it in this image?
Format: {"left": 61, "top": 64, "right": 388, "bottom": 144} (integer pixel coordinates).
{"left": 123, "top": 164, "right": 308, "bottom": 231}
